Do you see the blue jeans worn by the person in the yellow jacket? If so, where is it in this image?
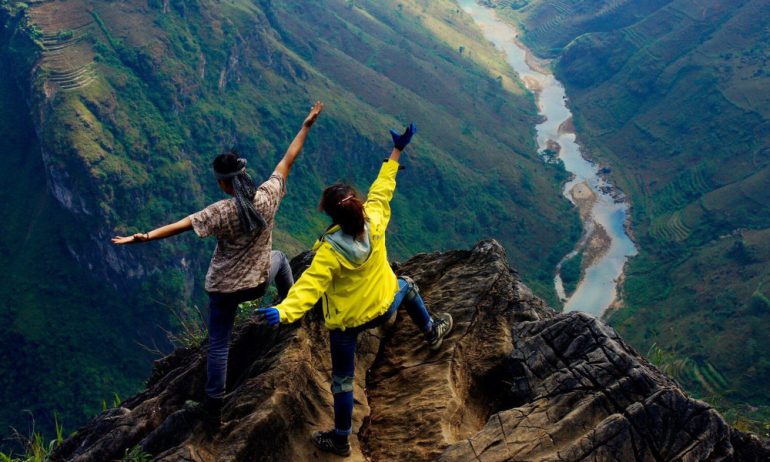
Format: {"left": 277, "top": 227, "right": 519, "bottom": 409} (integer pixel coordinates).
{"left": 329, "top": 278, "right": 433, "bottom": 435}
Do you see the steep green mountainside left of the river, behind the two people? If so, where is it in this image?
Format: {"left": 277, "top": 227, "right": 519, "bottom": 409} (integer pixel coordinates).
{"left": 0, "top": 0, "right": 580, "bottom": 444}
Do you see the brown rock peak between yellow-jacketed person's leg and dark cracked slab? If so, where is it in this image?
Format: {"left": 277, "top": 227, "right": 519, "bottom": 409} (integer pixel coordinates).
{"left": 363, "top": 241, "right": 553, "bottom": 460}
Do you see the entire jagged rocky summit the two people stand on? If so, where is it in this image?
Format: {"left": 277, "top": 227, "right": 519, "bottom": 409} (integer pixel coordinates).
{"left": 54, "top": 241, "right": 770, "bottom": 462}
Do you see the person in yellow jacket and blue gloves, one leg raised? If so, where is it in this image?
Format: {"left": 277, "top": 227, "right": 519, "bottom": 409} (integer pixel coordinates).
{"left": 257, "top": 124, "right": 452, "bottom": 456}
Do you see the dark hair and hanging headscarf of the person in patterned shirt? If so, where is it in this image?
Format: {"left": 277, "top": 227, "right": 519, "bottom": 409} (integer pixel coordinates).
{"left": 213, "top": 148, "right": 267, "bottom": 234}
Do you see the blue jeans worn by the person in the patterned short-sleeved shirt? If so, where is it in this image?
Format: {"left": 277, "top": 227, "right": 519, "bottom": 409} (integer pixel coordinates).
{"left": 206, "top": 250, "right": 294, "bottom": 398}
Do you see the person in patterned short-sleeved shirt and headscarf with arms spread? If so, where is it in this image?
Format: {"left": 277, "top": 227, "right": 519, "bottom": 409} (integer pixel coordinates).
{"left": 112, "top": 101, "right": 324, "bottom": 425}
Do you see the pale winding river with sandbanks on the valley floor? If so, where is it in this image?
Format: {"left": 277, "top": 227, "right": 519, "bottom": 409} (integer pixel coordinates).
{"left": 458, "top": 0, "right": 637, "bottom": 316}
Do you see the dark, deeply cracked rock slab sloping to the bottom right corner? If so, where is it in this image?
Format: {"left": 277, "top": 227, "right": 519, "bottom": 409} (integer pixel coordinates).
{"left": 440, "top": 313, "right": 770, "bottom": 462}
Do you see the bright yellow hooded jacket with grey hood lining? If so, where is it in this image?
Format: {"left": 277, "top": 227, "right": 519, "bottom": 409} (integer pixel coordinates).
{"left": 276, "top": 160, "right": 398, "bottom": 330}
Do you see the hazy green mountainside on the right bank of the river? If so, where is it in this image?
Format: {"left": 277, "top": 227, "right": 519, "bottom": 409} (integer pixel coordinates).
{"left": 496, "top": 0, "right": 770, "bottom": 432}
